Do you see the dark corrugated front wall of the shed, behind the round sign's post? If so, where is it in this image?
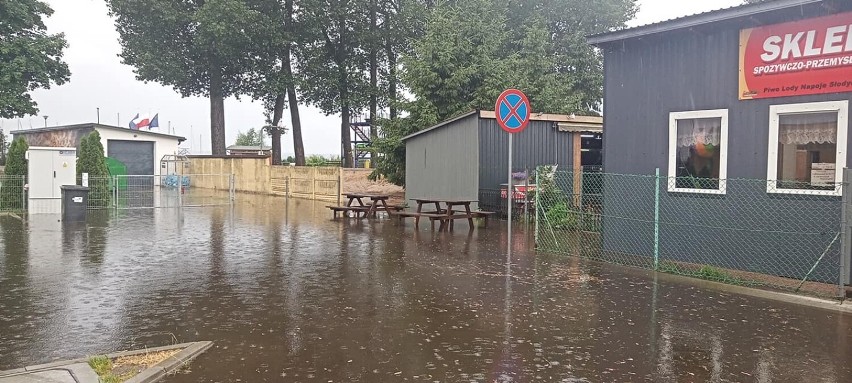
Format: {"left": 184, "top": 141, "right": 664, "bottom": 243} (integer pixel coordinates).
{"left": 479, "top": 118, "right": 573, "bottom": 210}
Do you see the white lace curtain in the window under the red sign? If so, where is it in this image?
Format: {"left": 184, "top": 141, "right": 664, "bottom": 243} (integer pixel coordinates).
{"left": 778, "top": 113, "right": 837, "bottom": 145}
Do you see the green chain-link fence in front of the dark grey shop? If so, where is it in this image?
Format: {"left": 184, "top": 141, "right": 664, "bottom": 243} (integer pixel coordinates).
{"left": 533, "top": 167, "right": 849, "bottom": 296}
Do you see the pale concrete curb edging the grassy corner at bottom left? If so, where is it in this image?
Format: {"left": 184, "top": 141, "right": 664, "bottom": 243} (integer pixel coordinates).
{"left": 0, "top": 341, "right": 213, "bottom": 383}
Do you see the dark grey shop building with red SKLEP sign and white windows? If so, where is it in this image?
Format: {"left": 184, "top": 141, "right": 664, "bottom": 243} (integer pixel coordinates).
{"left": 589, "top": 0, "right": 852, "bottom": 283}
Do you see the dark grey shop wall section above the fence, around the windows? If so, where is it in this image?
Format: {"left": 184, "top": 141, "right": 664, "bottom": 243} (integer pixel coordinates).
{"left": 604, "top": 2, "right": 852, "bottom": 178}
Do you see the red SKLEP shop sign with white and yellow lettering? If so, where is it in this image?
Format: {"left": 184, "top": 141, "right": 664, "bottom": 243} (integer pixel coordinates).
{"left": 739, "top": 12, "right": 852, "bottom": 100}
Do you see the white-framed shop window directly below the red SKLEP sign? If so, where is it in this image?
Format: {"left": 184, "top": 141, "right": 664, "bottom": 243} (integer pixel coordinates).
{"left": 766, "top": 101, "right": 849, "bottom": 196}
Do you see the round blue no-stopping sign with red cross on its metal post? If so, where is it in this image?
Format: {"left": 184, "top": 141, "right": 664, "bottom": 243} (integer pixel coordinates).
{"left": 494, "top": 89, "right": 530, "bottom": 246}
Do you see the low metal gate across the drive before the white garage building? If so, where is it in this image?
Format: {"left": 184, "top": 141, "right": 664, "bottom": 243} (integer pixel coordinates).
{"left": 88, "top": 174, "right": 235, "bottom": 209}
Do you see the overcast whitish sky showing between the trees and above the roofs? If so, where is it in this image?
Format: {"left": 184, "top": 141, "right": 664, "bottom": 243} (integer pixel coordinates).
{"left": 0, "top": 0, "right": 742, "bottom": 154}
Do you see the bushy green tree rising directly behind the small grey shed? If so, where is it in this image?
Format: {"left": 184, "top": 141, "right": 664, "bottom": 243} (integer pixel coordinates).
{"left": 372, "top": 0, "right": 636, "bottom": 184}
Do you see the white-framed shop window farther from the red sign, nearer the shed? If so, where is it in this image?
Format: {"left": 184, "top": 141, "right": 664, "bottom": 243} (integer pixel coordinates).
{"left": 668, "top": 109, "right": 728, "bottom": 194}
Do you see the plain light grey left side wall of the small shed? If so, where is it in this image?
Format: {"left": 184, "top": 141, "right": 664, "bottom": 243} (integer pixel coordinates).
{"left": 405, "top": 115, "right": 479, "bottom": 204}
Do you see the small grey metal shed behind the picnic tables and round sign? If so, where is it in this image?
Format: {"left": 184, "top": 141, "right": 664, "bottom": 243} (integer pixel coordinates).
{"left": 403, "top": 111, "right": 602, "bottom": 211}
